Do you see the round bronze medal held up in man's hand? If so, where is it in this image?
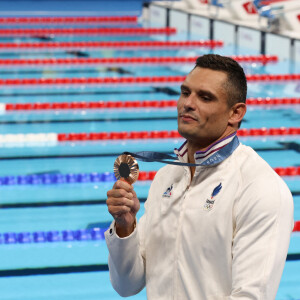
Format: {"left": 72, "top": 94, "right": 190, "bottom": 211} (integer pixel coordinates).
{"left": 114, "top": 154, "right": 139, "bottom": 184}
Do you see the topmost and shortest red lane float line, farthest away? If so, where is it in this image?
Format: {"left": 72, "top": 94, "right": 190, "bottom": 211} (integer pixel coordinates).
{"left": 0, "top": 16, "right": 138, "bottom": 25}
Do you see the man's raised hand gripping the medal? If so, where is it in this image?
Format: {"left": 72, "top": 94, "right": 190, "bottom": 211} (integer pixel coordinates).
{"left": 106, "top": 180, "right": 140, "bottom": 237}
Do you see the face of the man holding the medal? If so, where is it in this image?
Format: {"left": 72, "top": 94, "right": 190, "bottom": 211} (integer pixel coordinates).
{"left": 177, "top": 67, "right": 231, "bottom": 148}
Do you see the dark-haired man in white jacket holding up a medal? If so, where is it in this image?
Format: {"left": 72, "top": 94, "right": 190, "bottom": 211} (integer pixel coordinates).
{"left": 105, "top": 55, "right": 293, "bottom": 300}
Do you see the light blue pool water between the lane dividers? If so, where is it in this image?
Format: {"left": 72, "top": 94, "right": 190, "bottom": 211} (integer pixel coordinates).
{"left": 0, "top": 14, "right": 300, "bottom": 300}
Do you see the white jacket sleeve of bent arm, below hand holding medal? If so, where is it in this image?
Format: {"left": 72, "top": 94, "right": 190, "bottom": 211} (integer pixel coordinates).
{"left": 105, "top": 209, "right": 145, "bottom": 297}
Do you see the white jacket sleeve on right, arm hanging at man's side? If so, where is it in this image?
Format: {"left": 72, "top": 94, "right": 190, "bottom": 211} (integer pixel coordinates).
{"left": 226, "top": 174, "right": 294, "bottom": 300}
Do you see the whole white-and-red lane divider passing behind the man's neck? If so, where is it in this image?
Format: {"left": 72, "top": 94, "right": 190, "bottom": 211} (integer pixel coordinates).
{"left": 0, "top": 127, "right": 300, "bottom": 147}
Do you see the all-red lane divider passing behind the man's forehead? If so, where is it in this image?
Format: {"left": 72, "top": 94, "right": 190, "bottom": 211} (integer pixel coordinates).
{"left": 0, "top": 74, "right": 300, "bottom": 88}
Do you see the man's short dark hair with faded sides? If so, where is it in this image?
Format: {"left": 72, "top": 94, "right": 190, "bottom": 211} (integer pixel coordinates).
{"left": 195, "top": 54, "right": 247, "bottom": 107}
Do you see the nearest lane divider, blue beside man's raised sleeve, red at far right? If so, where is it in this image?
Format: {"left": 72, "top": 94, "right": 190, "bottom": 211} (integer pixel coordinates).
{"left": 0, "top": 221, "right": 300, "bottom": 245}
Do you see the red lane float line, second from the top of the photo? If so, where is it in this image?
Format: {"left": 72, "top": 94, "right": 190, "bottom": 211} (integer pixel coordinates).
{"left": 0, "top": 27, "right": 176, "bottom": 37}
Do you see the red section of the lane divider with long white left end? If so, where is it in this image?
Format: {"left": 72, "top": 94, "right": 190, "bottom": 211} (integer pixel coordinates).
{"left": 57, "top": 127, "right": 300, "bottom": 142}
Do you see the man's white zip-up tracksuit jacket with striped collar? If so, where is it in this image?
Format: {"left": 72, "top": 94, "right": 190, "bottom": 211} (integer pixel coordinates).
{"left": 105, "top": 136, "right": 294, "bottom": 300}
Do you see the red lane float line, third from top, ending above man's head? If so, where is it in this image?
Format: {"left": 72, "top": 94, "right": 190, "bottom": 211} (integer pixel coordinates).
{"left": 0, "top": 40, "right": 223, "bottom": 51}
